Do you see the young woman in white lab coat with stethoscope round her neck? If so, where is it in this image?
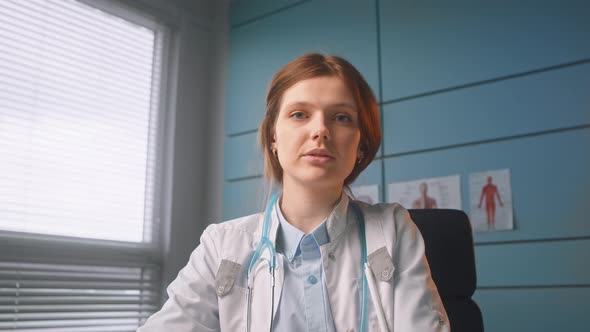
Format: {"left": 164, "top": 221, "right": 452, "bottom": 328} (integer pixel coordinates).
{"left": 139, "top": 54, "right": 450, "bottom": 332}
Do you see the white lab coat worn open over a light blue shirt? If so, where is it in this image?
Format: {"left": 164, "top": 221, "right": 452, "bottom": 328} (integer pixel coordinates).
{"left": 138, "top": 194, "right": 450, "bottom": 332}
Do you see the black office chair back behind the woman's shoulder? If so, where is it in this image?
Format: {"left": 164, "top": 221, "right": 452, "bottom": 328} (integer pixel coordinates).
{"left": 409, "top": 209, "right": 483, "bottom": 332}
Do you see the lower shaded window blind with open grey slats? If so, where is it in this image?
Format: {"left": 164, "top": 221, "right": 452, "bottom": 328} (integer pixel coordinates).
{"left": 0, "top": 262, "right": 160, "bottom": 332}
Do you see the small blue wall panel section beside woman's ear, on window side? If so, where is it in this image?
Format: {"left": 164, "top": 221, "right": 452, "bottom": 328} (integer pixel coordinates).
{"left": 224, "top": 132, "right": 264, "bottom": 180}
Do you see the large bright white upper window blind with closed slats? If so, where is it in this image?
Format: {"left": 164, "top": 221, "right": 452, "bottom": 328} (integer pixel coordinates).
{"left": 0, "top": 0, "right": 162, "bottom": 242}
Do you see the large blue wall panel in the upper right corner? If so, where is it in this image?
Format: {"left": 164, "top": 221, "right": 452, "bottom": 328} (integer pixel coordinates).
{"left": 379, "top": 0, "right": 590, "bottom": 101}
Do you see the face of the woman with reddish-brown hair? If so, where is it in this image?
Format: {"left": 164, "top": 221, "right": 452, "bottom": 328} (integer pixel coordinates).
{"left": 272, "top": 76, "right": 360, "bottom": 187}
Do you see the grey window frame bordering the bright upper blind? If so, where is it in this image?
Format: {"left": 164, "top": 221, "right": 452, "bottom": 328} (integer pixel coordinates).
{"left": 0, "top": 0, "right": 180, "bottom": 326}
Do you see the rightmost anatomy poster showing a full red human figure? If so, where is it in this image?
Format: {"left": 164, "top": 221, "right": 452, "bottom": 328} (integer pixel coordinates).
{"left": 469, "top": 169, "right": 513, "bottom": 232}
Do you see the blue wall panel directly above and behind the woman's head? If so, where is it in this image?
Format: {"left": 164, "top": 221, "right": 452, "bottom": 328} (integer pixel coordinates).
{"left": 225, "top": 0, "right": 378, "bottom": 134}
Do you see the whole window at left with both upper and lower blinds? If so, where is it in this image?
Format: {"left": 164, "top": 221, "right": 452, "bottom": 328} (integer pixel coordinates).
{"left": 0, "top": 0, "right": 168, "bottom": 332}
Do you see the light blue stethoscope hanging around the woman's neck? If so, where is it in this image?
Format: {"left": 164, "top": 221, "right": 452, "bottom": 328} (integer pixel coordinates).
{"left": 246, "top": 193, "right": 389, "bottom": 332}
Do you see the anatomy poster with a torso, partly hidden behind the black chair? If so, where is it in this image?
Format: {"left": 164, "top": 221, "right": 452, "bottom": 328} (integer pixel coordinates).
{"left": 387, "top": 175, "right": 461, "bottom": 210}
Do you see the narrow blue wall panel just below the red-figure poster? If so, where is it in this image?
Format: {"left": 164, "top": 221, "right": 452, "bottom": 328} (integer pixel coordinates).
{"left": 475, "top": 238, "right": 590, "bottom": 287}
